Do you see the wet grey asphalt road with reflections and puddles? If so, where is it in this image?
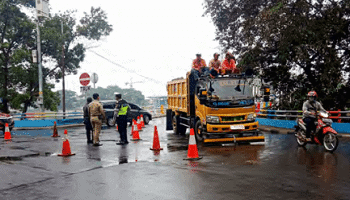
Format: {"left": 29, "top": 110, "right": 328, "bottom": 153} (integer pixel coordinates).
{"left": 0, "top": 118, "right": 350, "bottom": 199}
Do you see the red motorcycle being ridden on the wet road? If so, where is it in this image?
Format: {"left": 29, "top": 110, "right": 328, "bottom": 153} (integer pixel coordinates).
{"left": 295, "top": 111, "right": 339, "bottom": 152}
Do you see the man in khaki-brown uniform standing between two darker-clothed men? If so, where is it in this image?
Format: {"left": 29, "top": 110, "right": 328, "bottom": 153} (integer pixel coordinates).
{"left": 89, "top": 93, "right": 106, "bottom": 146}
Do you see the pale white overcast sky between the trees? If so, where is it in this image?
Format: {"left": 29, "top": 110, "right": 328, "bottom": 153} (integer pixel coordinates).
{"left": 50, "top": 0, "right": 220, "bottom": 97}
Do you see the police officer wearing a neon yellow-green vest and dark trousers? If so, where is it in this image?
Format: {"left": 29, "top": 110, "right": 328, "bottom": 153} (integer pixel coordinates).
{"left": 114, "top": 93, "right": 130, "bottom": 145}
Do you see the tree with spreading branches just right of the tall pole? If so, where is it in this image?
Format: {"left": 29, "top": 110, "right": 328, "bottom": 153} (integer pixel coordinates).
{"left": 41, "top": 7, "right": 113, "bottom": 112}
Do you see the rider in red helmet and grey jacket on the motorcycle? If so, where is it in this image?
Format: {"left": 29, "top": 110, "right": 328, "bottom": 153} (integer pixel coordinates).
{"left": 303, "top": 91, "right": 327, "bottom": 142}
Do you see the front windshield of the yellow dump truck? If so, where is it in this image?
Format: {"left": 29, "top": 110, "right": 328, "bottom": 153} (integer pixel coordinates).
{"left": 208, "top": 79, "right": 253, "bottom": 100}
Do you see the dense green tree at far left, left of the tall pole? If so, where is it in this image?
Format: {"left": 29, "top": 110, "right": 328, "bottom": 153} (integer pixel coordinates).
{"left": 0, "top": 0, "right": 58, "bottom": 113}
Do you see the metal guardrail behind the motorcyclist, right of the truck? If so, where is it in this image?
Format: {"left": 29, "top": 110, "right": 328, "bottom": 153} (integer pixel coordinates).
{"left": 255, "top": 109, "right": 350, "bottom": 123}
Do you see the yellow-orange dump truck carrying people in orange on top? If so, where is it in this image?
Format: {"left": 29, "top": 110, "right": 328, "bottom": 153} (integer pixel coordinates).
{"left": 166, "top": 73, "right": 265, "bottom": 143}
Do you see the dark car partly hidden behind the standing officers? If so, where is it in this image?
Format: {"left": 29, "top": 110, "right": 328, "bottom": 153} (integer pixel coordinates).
{"left": 100, "top": 100, "right": 152, "bottom": 127}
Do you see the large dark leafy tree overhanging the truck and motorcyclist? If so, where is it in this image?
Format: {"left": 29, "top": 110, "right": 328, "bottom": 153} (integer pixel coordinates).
{"left": 205, "top": 0, "right": 350, "bottom": 109}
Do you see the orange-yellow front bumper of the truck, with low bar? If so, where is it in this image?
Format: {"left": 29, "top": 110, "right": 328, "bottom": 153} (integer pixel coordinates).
{"left": 203, "top": 122, "right": 265, "bottom": 143}
